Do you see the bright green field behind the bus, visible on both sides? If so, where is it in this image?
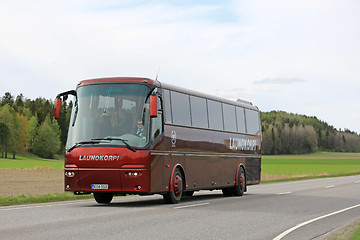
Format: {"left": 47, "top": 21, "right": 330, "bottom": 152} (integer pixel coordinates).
{"left": 0, "top": 152, "right": 360, "bottom": 176}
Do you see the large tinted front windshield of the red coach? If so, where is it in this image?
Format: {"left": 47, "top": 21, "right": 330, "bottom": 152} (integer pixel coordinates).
{"left": 66, "top": 84, "right": 150, "bottom": 150}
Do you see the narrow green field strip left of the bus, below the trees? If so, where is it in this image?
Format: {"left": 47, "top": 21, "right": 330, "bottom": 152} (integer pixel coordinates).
{"left": 0, "top": 154, "right": 64, "bottom": 170}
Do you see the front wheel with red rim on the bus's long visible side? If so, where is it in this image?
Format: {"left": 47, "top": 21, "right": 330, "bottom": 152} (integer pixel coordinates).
{"left": 163, "top": 168, "right": 184, "bottom": 204}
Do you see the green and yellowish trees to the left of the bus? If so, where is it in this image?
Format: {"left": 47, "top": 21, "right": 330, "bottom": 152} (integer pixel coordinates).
{"left": 0, "top": 92, "right": 72, "bottom": 159}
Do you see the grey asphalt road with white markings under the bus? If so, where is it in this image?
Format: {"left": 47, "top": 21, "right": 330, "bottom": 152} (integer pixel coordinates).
{"left": 0, "top": 176, "right": 360, "bottom": 240}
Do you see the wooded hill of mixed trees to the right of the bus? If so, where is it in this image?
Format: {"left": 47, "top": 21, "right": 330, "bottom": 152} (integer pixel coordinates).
{"left": 260, "top": 111, "right": 360, "bottom": 154}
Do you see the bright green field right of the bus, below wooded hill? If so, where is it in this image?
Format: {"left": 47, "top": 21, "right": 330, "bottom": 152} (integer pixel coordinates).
{"left": 262, "top": 152, "right": 360, "bottom": 177}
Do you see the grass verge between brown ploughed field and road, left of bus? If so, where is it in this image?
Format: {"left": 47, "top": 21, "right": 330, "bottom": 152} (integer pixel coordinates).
{"left": 0, "top": 192, "right": 93, "bottom": 206}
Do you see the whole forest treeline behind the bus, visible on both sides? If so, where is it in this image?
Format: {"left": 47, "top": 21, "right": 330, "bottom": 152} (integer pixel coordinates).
{"left": 0, "top": 92, "right": 360, "bottom": 158}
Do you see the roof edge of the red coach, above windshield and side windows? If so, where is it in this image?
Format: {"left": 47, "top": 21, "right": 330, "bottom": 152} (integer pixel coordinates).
{"left": 78, "top": 77, "right": 259, "bottom": 111}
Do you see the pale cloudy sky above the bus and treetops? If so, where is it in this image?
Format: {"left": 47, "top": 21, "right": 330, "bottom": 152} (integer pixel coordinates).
{"left": 0, "top": 0, "right": 360, "bottom": 133}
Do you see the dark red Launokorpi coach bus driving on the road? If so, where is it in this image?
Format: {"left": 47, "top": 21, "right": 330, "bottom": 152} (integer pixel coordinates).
{"left": 55, "top": 78, "right": 261, "bottom": 203}
